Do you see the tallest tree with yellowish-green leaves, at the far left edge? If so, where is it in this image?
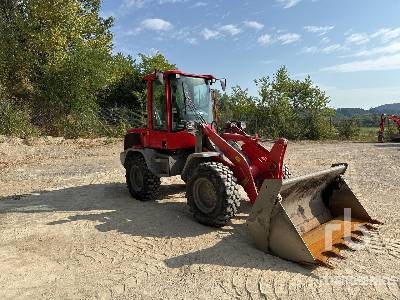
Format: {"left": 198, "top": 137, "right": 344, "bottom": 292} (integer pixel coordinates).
{"left": 0, "top": 0, "right": 112, "bottom": 134}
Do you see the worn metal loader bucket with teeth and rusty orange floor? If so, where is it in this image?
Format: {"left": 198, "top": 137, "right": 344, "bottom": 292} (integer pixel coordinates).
{"left": 247, "top": 165, "right": 379, "bottom": 267}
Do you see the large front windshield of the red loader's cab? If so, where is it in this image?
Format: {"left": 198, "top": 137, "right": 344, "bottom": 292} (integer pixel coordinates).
{"left": 170, "top": 74, "right": 213, "bottom": 131}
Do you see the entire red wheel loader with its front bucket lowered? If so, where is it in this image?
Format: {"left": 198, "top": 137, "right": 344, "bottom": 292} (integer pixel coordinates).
{"left": 121, "top": 70, "right": 379, "bottom": 266}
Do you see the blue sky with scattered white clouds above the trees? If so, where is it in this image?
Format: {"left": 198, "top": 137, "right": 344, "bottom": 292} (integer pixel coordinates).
{"left": 102, "top": 0, "right": 400, "bottom": 108}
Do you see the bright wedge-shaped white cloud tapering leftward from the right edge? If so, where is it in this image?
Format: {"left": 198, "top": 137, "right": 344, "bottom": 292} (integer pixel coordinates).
{"left": 322, "top": 54, "right": 400, "bottom": 73}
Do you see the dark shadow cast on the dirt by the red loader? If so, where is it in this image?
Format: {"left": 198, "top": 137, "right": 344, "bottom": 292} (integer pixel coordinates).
{"left": 0, "top": 183, "right": 312, "bottom": 275}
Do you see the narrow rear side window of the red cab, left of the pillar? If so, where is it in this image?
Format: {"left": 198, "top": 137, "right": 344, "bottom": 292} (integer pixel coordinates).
{"left": 152, "top": 80, "right": 167, "bottom": 131}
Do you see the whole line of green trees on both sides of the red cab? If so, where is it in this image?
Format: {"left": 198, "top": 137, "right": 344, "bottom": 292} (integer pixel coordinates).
{"left": 0, "top": 0, "right": 368, "bottom": 140}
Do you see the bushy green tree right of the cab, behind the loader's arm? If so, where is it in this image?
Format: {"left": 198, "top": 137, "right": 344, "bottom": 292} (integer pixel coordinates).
{"left": 255, "top": 67, "right": 333, "bottom": 139}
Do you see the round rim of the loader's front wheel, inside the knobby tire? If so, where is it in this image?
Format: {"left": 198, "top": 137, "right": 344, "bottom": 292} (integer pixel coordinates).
{"left": 193, "top": 178, "right": 218, "bottom": 214}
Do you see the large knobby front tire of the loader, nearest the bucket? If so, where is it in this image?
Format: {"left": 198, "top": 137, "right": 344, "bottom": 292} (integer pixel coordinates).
{"left": 186, "top": 162, "right": 240, "bottom": 227}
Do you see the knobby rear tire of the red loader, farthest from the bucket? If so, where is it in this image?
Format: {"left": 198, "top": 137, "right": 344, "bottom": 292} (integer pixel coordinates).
{"left": 126, "top": 155, "right": 161, "bottom": 201}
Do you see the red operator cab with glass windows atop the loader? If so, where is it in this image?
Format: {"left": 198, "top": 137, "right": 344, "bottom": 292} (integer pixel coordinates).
{"left": 128, "top": 70, "right": 226, "bottom": 151}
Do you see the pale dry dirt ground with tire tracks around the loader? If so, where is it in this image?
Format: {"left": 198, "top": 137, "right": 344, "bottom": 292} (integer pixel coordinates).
{"left": 0, "top": 138, "right": 400, "bottom": 299}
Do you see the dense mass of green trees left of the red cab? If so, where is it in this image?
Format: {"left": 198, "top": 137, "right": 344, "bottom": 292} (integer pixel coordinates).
{"left": 0, "top": 0, "right": 175, "bottom": 137}
